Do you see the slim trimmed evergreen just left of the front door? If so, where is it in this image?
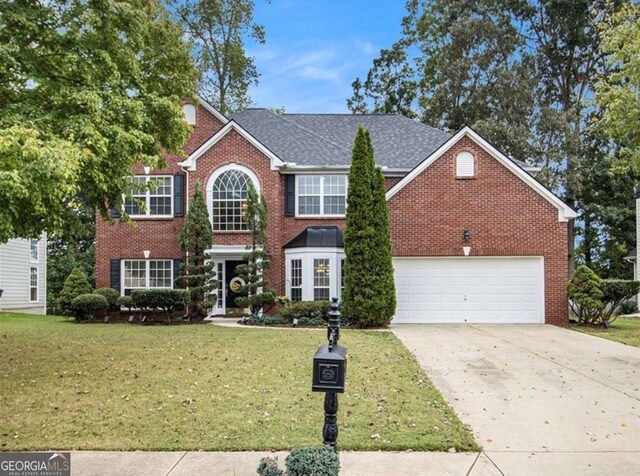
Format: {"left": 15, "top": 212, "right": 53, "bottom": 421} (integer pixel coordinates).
{"left": 176, "top": 182, "right": 218, "bottom": 319}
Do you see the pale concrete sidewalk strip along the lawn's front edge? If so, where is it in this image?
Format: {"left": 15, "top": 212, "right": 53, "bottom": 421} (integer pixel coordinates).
{"left": 71, "top": 451, "right": 501, "bottom": 476}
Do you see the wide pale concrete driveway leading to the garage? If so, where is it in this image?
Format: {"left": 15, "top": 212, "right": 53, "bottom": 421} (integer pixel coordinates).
{"left": 392, "top": 324, "right": 640, "bottom": 475}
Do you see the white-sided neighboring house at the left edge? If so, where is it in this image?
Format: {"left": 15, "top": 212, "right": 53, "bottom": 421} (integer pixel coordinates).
{"left": 0, "top": 235, "right": 47, "bottom": 314}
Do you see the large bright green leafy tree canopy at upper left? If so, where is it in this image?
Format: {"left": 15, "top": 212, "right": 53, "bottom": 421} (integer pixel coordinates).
{"left": 0, "top": 0, "right": 196, "bottom": 243}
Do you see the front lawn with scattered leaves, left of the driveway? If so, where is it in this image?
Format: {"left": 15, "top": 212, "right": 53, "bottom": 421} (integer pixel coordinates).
{"left": 0, "top": 313, "right": 478, "bottom": 451}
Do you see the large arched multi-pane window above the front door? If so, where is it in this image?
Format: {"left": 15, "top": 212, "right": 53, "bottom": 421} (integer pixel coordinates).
{"left": 211, "top": 169, "right": 251, "bottom": 231}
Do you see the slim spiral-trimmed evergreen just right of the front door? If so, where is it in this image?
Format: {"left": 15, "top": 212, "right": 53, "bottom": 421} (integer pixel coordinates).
{"left": 236, "top": 182, "right": 276, "bottom": 316}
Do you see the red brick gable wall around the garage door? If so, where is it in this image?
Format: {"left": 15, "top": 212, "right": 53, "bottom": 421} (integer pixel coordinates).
{"left": 389, "top": 137, "right": 568, "bottom": 324}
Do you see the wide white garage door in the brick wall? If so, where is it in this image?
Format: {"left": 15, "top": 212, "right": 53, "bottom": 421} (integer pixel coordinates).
{"left": 393, "top": 257, "right": 544, "bottom": 324}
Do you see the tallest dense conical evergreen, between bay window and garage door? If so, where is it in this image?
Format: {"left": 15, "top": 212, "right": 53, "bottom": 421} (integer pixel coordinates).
{"left": 342, "top": 127, "right": 395, "bottom": 327}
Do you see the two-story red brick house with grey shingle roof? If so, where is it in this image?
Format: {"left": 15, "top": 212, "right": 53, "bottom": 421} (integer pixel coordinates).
{"left": 96, "top": 101, "right": 576, "bottom": 324}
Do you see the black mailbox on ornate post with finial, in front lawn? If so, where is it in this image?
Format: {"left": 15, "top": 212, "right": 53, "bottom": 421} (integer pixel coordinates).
{"left": 311, "top": 298, "right": 347, "bottom": 451}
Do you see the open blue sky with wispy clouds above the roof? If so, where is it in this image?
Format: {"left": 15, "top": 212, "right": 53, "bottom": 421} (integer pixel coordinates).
{"left": 246, "top": 0, "right": 405, "bottom": 112}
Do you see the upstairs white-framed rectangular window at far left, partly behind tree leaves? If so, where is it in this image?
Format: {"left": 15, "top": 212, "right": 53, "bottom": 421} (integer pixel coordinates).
{"left": 124, "top": 175, "right": 173, "bottom": 217}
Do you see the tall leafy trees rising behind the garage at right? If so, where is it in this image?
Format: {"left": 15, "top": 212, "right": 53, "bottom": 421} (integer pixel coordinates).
{"left": 347, "top": 0, "right": 640, "bottom": 277}
